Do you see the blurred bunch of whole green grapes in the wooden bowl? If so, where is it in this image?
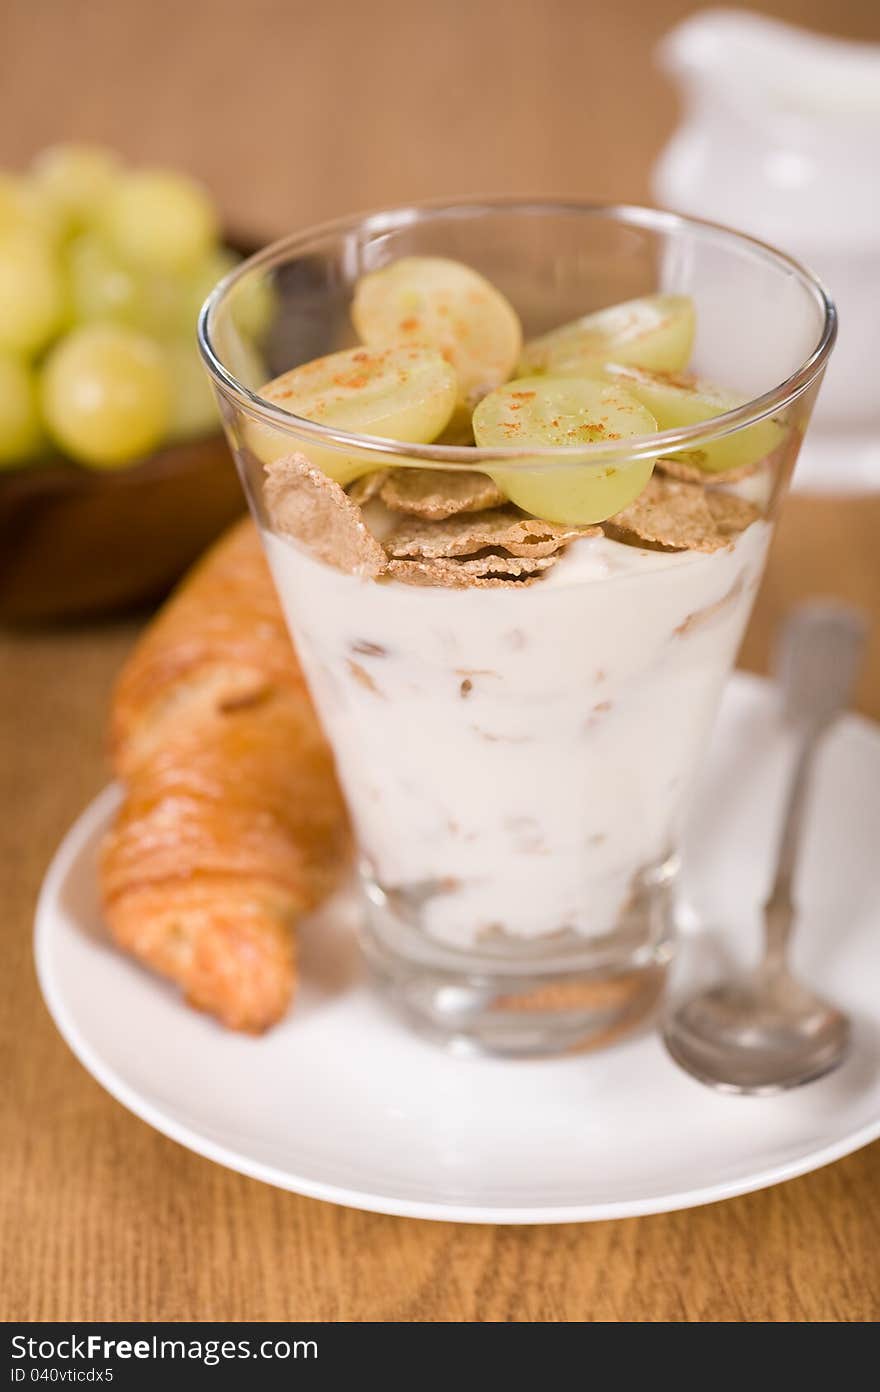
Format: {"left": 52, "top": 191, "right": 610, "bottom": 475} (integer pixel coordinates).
{"left": 0, "top": 145, "right": 272, "bottom": 469}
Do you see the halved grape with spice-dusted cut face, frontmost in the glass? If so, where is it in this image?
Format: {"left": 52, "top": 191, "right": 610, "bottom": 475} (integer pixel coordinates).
{"left": 473, "top": 377, "right": 657, "bottom": 523}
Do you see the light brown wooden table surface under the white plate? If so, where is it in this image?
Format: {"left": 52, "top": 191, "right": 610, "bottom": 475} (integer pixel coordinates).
{"left": 0, "top": 0, "right": 880, "bottom": 1321}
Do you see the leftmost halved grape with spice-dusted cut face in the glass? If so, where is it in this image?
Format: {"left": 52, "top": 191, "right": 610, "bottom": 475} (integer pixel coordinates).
{"left": 246, "top": 348, "right": 458, "bottom": 484}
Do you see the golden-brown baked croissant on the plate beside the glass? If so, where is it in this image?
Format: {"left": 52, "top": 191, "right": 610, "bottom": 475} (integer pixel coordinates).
{"left": 100, "top": 521, "right": 348, "bottom": 1031}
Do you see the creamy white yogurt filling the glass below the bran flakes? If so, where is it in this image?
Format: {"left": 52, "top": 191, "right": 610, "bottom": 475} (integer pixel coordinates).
{"left": 265, "top": 522, "right": 770, "bottom": 948}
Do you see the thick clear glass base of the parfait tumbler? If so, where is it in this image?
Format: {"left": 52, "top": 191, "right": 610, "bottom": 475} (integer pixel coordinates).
{"left": 361, "top": 863, "right": 674, "bottom": 1058}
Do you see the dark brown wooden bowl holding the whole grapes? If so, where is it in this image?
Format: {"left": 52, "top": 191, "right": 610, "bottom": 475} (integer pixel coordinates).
{"left": 0, "top": 434, "right": 245, "bottom": 624}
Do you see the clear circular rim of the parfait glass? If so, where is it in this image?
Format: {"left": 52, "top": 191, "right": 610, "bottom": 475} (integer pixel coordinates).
{"left": 198, "top": 195, "right": 837, "bottom": 469}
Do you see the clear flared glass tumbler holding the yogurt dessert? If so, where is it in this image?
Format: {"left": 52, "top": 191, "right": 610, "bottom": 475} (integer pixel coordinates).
{"left": 199, "top": 200, "right": 835, "bottom": 1055}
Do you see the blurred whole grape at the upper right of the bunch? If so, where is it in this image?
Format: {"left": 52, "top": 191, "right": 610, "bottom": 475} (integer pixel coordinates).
{"left": 100, "top": 170, "right": 217, "bottom": 273}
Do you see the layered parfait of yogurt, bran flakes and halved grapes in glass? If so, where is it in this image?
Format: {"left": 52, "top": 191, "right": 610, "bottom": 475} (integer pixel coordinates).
{"left": 202, "top": 207, "right": 830, "bottom": 1054}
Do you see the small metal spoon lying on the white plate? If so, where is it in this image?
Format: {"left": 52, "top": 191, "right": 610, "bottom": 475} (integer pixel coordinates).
{"left": 663, "top": 603, "right": 867, "bottom": 1094}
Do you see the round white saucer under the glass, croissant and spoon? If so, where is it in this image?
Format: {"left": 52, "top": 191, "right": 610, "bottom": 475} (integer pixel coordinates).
{"left": 36, "top": 677, "right": 880, "bottom": 1224}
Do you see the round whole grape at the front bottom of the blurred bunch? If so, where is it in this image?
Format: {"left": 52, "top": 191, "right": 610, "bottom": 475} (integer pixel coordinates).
{"left": 42, "top": 324, "right": 171, "bottom": 469}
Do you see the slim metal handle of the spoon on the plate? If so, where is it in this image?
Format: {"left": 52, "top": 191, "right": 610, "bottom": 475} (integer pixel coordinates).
{"left": 762, "top": 603, "right": 867, "bottom": 973}
